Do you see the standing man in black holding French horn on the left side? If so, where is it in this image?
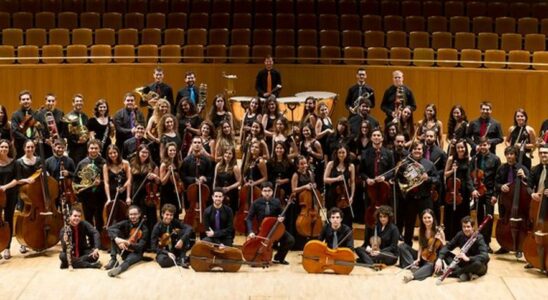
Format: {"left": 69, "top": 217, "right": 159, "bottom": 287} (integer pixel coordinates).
{"left": 74, "top": 140, "right": 106, "bottom": 231}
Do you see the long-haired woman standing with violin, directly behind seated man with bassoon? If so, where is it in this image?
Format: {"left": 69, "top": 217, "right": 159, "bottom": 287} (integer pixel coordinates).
{"left": 444, "top": 140, "right": 479, "bottom": 239}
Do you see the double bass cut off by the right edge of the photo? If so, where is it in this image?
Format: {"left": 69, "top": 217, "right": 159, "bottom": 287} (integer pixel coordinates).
{"left": 523, "top": 165, "right": 548, "bottom": 274}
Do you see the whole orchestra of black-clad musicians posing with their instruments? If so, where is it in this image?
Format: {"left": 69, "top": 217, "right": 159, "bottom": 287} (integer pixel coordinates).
{"left": 0, "top": 57, "right": 548, "bottom": 282}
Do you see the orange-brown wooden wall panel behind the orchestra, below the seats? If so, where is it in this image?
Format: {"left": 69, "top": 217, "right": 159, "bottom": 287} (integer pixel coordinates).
{"left": 0, "top": 64, "right": 548, "bottom": 135}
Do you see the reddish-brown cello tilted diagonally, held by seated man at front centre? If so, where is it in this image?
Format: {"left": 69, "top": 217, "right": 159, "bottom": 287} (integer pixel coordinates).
{"left": 242, "top": 194, "right": 294, "bottom": 263}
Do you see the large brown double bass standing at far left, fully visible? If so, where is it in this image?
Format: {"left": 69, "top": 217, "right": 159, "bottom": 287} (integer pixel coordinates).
{"left": 14, "top": 130, "right": 64, "bottom": 251}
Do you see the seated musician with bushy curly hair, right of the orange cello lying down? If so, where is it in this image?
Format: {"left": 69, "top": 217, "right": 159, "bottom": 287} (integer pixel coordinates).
{"left": 355, "top": 205, "right": 400, "bottom": 265}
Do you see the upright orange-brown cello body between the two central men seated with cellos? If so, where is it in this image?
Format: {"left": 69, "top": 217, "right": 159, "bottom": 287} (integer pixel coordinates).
{"left": 295, "top": 188, "right": 323, "bottom": 238}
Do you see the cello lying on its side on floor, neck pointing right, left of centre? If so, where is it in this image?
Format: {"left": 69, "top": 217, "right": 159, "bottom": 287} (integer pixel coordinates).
{"left": 190, "top": 241, "right": 268, "bottom": 272}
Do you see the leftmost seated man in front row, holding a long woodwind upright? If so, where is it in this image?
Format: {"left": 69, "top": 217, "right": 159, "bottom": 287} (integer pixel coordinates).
{"left": 59, "top": 207, "right": 101, "bottom": 269}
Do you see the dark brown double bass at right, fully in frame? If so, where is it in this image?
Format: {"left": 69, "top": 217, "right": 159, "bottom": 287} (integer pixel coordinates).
{"left": 496, "top": 142, "right": 531, "bottom": 256}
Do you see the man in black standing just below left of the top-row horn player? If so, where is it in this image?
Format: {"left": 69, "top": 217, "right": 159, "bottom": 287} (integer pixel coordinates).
{"left": 114, "top": 93, "right": 145, "bottom": 149}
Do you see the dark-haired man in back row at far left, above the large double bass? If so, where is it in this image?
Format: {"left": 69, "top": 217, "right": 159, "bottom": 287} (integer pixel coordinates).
{"left": 11, "top": 90, "right": 37, "bottom": 155}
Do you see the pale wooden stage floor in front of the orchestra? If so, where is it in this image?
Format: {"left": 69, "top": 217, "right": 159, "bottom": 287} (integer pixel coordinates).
{"left": 0, "top": 237, "right": 548, "bottom": 300}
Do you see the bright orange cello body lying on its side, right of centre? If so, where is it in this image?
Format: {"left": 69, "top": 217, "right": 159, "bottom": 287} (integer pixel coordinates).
{"left": 302, "top": 240, "right": 355, "bottom": 275}
